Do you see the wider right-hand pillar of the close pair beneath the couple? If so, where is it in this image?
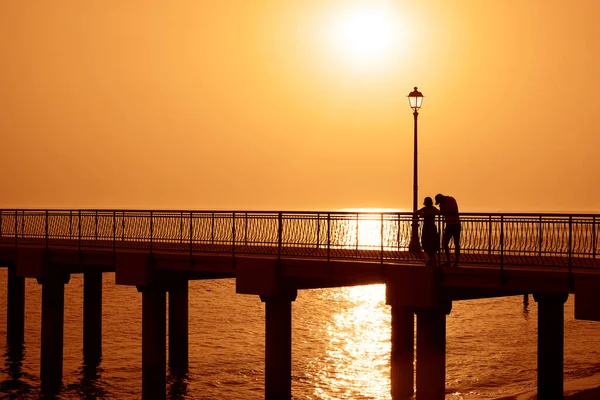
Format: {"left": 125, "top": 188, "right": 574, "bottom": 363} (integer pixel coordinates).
{"left": 416, "top": 301, "right": 452, "bottom": 400}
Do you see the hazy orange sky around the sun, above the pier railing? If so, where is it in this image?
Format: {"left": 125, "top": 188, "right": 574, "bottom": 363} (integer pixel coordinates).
{"left": 0, "top": 0, "right": 600, "bottom": 212}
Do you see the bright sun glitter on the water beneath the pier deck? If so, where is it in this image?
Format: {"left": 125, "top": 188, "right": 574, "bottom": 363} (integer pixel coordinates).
{"left": 314, "top": 285, "right": 391, "bottom": 399}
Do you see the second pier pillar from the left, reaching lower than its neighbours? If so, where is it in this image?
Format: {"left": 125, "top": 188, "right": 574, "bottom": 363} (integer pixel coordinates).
{"left": 38, "top": 274, "right": 70, "bottom": 395}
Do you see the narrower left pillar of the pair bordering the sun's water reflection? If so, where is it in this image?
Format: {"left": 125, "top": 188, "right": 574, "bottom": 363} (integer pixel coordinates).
{"left": 390, "top": 306, "right": 415, "bottom": 400}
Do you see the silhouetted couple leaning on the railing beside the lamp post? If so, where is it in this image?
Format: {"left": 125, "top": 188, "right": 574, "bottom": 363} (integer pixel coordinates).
{"left": 417, "top": 193, "right": 461, "bottom": 267}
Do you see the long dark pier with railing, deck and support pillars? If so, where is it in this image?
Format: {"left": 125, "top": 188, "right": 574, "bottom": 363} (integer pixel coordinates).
{"left": 0, "top": 210, "right": 600, "bottom": 400}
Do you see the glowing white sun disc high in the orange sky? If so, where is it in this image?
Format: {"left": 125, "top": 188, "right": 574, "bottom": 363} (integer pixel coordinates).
{"left": 328, "top": 5, "right": 403, "bottom": 66}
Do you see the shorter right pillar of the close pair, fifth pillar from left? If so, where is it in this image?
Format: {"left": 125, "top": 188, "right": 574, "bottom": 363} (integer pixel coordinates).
{"left": 169, "top": 279, "right": 189, "bottom": 375}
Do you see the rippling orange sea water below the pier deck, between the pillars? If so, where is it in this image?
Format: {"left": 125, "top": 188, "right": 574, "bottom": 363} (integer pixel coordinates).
{"left": 0, "top": 269, "right": 600, "bottom": 400}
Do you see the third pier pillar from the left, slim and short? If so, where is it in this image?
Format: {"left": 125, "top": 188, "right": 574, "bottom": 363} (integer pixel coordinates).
{"left": 83, "top": 271, "right": 102, "bottom": 365}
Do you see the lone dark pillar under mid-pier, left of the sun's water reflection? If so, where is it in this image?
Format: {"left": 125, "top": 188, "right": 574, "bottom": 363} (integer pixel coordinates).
{"left": 260, "top": 290, "right": 298, "bottom": 400}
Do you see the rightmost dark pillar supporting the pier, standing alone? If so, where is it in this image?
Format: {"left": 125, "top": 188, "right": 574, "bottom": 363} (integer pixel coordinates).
{"left": 533, "top": 293, "right": 569, "bottom": 400}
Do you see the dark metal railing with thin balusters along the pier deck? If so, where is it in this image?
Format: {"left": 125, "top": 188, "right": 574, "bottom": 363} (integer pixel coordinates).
{"left": 0, "top": 209, "right": 600, "bottom": 268}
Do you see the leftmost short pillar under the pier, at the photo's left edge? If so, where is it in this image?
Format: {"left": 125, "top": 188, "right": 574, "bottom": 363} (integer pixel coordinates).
{"left": 6, "top": 265, "right": 25, "bottom": 347}
